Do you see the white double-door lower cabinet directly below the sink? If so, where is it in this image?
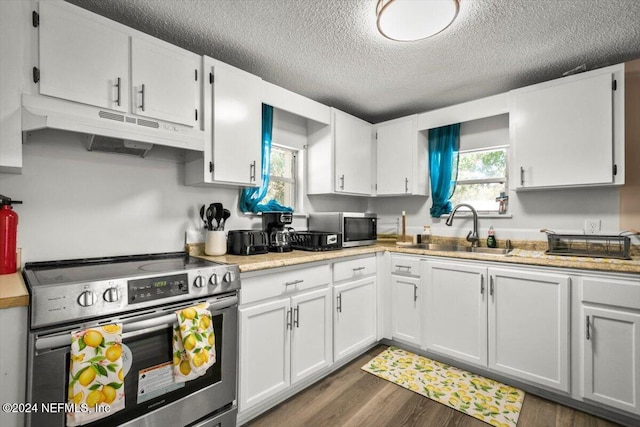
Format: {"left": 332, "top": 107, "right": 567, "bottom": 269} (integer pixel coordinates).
{"left": 425, "top": 261, "right": 570, "bottom": 392}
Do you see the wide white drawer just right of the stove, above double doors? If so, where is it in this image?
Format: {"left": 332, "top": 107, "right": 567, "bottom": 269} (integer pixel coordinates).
{"left": 240, "top": 264, "right": 331, "bottom": 304}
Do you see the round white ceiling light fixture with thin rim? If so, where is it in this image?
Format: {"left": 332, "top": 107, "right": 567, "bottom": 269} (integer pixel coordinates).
{"left": 376, "top": 0, "right": 458, "bottom": 41}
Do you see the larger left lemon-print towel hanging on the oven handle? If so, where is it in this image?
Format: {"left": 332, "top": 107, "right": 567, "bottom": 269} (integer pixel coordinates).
{"left": 67, "top": 323, "right": 124, "bottom": 426}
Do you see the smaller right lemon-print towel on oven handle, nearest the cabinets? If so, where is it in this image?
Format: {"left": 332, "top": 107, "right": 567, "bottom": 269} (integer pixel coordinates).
{"left": 173, "top": 303, "right": 216, "bottom": 382}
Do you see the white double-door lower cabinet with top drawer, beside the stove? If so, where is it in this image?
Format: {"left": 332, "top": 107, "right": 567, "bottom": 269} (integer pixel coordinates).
{"left": 239, "top": 265, "right": 333, "bottom": 411}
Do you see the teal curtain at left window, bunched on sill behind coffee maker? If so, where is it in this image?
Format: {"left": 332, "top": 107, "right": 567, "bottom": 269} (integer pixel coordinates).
{"left": 240, "top": 104, "right": 293, "bottom": 213}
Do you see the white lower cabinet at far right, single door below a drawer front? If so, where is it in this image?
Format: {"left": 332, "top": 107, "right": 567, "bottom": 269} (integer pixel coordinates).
{"left": 577, "top": 278, "right": 640, "bottom": 414}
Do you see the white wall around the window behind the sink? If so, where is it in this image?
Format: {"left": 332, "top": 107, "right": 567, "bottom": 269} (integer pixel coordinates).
{"left": 369, "top": 115, "right": 620, "bottom": 244}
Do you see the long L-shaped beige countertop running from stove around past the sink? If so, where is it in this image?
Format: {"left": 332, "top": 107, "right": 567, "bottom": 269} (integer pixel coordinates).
{"left": 187, "top": 243, "right": 640, "bottom": 273}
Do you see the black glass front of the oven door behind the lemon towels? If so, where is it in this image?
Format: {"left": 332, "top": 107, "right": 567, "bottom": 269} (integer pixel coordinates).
{"left": 83, "top": 314, "right": 223, "bottom": 426}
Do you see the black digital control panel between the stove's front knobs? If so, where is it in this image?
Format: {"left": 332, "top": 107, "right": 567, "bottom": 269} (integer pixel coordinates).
{"left": 127, "top": 273, "right": 189, "bottom": 304}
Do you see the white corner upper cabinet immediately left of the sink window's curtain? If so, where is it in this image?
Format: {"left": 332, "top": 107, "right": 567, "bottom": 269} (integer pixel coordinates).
{"left": 375, "top": 114, "right": 429, "bottom": 196}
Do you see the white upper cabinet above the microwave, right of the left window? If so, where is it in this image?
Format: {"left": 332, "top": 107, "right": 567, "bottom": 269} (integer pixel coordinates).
{"left": 307, "top": 108, "right": 373, "bottom": 196}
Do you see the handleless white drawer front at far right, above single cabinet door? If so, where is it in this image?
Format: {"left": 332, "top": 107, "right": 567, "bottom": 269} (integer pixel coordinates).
{"left": 582, "top": 277, "right": 640, "bottom": 310}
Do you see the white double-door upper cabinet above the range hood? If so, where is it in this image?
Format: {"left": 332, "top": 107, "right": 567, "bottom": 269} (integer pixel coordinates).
{"left": 31, "top": 2, "right": 201, "bottom": 129}
